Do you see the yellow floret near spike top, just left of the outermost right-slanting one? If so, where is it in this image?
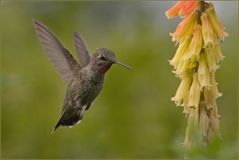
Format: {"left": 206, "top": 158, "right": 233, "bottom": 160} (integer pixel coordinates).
{"left": 201, "top": 13, "right": 216, "bottom": 47}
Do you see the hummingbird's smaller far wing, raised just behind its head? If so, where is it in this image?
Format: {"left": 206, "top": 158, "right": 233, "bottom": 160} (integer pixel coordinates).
{"left": 73, "top": 32, "right": 90, "bottom": 68}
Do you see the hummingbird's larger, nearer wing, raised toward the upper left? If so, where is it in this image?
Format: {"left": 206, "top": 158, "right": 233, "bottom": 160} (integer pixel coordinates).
{"left": 33, "top": 20, "right": 80, "bottom": 82}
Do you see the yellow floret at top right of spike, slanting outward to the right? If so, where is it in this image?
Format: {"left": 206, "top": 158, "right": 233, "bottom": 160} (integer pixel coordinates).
{"left": 206, "top": 3, "right": 228, "bottom": 40}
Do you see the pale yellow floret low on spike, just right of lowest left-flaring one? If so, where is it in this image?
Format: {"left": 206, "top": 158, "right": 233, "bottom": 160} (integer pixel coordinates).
{"left": 187, "top": 73, "right": 201, "bottom": 108}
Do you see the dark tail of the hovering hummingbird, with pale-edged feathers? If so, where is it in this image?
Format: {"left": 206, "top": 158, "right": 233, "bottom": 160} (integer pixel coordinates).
{"left": 52, "top": 107, "right": 86, "bottom": 133}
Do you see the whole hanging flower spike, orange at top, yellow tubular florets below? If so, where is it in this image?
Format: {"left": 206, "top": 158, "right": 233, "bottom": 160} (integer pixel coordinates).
{"left": 166, "top": 0, "right": 228, "bottom": 147}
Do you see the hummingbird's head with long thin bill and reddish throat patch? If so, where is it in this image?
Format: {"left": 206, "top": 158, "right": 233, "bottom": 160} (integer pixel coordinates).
{"left": 92, "top": 48, "right": 131, "bottom": 74}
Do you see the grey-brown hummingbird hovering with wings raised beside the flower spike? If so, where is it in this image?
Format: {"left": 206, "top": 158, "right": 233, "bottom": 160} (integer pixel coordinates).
{"left": 33, "top": 20, "right": 132, "bottom": 133}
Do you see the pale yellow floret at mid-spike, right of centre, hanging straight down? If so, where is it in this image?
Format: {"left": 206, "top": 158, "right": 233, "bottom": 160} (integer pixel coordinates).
{"left": 198, "top": 52, "right": 210, "bottom": 89}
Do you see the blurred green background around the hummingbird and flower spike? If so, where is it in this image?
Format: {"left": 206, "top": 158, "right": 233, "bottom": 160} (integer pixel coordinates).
{"left": 0, "top": 1, "right": 239, "bottom": 159}
